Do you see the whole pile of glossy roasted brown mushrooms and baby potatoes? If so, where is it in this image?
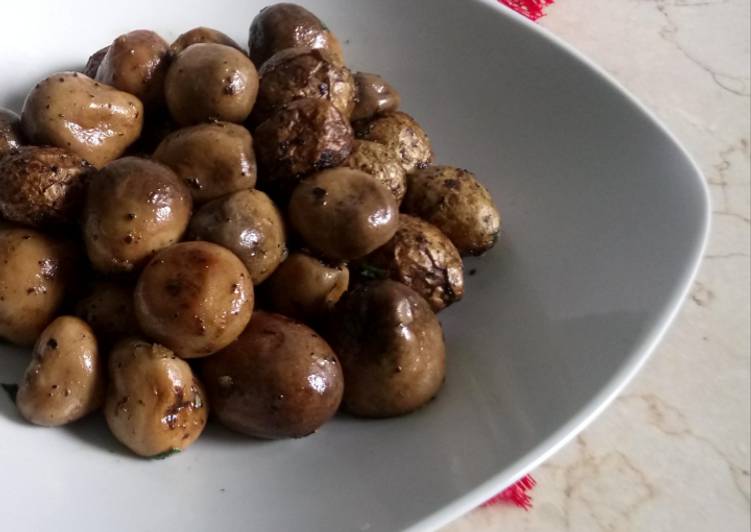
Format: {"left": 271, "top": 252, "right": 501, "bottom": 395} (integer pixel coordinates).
{"left": 0, "top": 3, "right": 500, "bottom": 457}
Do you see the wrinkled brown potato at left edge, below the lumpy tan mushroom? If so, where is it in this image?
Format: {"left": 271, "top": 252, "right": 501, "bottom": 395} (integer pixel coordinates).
{"left": 0, "top": 146, "right": 92, "bottom": 227}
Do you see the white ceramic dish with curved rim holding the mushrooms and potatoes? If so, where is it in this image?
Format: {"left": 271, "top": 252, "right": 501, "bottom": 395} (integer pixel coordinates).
{"left": 0, "top": 0, "right": 708, "bottom": 532}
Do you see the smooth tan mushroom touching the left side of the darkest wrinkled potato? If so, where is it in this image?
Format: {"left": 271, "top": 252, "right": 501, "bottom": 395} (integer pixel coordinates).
{"left": 154, "top": 122, "right": 256, "bottom": 203}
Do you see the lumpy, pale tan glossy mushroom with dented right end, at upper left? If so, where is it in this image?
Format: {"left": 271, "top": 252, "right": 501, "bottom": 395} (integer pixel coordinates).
{"left": 21, "top": 72, "right": 143, "bottom": 168}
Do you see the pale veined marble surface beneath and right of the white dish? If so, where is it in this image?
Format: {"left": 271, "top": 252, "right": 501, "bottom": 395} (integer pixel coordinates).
{"left": 444, "top": 0, "right": 751, "bottom": 532}
